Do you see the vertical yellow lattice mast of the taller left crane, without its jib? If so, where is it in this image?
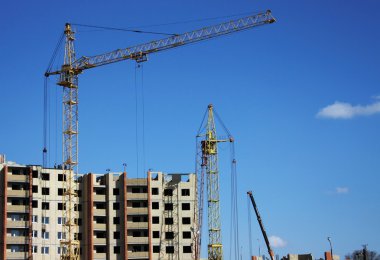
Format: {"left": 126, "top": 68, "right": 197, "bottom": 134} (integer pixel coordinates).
{"left": 57, "top": 24, "right": 80, "bottom": 260}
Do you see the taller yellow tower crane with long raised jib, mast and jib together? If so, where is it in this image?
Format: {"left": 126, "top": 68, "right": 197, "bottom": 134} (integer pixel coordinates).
{"left": 44, "top": 10, "right": 275, "bottom": 260}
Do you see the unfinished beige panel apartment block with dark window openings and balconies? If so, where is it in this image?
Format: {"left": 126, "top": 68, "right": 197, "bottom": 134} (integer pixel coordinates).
{"left": 0, "top": 155, "right": 198, "bottom": 260}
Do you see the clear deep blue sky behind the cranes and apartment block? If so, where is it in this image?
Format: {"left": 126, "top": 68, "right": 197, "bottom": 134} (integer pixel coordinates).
{"left": 0, "top": 0, "right": 380, "bottom": 259}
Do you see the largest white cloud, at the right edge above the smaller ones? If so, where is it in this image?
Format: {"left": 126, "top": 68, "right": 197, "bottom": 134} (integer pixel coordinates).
{"left": 317, "top": 97, "right": 380, "bottom": 119}
